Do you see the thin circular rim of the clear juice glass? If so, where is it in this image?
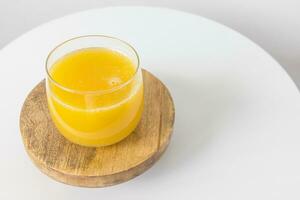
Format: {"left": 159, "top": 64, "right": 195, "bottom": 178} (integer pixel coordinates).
{"left": 45, "top": 34, "right": 140, "bottom": 94}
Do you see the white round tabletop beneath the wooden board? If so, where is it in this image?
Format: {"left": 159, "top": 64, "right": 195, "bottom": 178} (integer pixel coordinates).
{"left": 0, "top": 7, "right": 300, "bottom": 200}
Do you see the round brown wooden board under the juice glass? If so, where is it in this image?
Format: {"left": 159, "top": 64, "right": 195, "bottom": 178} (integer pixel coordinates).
{"left": 20, "top": 70, "right": 175, "bottom": 187}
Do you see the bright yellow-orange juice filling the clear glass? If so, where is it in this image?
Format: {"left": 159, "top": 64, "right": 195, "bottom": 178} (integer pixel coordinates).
{"left": 47, "top": 48, "right": 143, "bottom": 146}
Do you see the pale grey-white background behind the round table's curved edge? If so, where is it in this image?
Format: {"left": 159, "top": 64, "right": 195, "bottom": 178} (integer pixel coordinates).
{"left": 0, "top": 0, "right": 300, "bottom": 87}
